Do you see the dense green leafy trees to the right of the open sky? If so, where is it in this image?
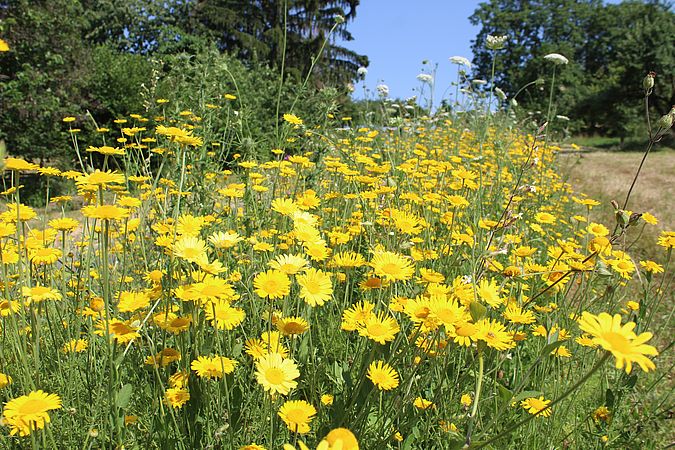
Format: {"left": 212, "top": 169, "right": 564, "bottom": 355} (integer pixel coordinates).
{"left": 470, "top": 0, "right": 675, "bottom": 137}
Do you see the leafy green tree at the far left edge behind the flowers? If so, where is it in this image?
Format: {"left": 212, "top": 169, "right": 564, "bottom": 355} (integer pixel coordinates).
{"left": 0, "top": 0, "right": 90, "bottom": 159}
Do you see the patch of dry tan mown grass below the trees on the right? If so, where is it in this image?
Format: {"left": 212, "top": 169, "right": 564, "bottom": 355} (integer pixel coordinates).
{"left": 560, "top": 151, "right": 675, "bottom": 260}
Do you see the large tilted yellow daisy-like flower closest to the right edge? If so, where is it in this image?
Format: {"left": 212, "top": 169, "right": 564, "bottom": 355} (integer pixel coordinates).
{"left": 579, "top": 311, "right": 658, "bottom": 373}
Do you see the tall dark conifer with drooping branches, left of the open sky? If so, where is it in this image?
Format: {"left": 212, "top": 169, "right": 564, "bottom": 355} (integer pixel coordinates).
{"left": 191, "top": 0, "right": 368, "bottom": 85}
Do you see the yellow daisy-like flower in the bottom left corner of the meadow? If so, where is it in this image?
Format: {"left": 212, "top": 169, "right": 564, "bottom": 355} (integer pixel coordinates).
{"left": 2, "top": 390, "right": 61, "bottom": 436}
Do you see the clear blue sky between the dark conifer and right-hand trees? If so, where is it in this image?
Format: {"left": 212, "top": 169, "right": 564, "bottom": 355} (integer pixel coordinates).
{"left": 344, "top": 0, "right": 619, "bottom": 105}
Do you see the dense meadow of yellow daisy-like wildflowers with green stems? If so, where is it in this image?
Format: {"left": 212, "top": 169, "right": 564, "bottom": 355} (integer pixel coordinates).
{"left": 0, "top": 14, "right": 675, "bottom": 450}
